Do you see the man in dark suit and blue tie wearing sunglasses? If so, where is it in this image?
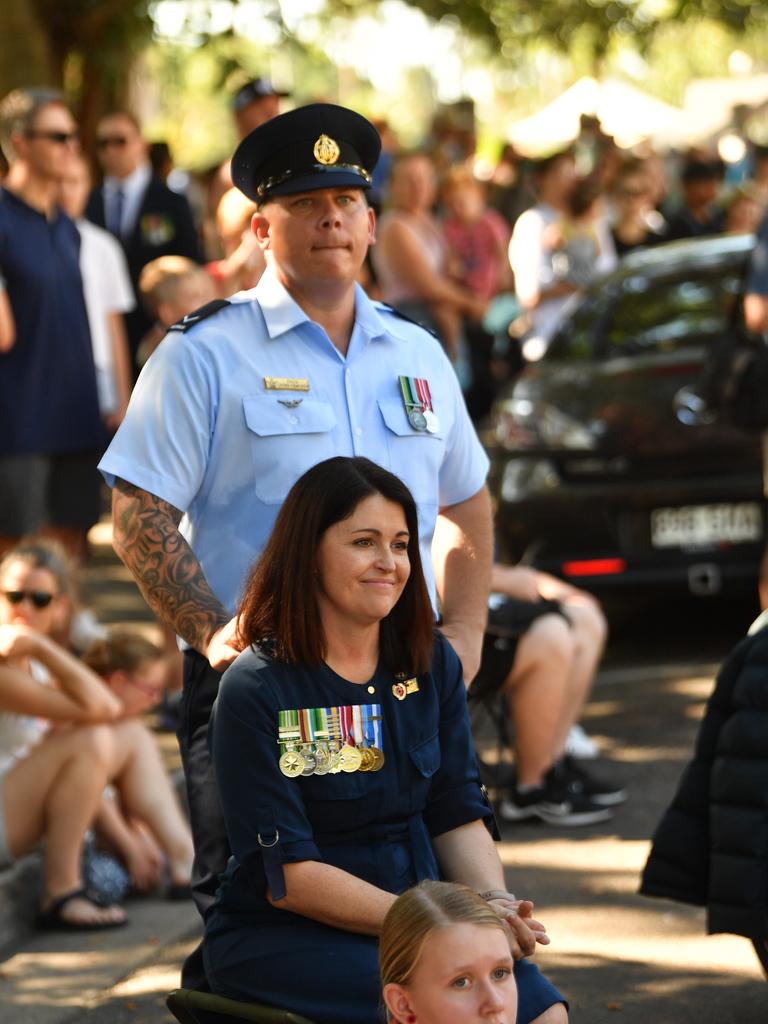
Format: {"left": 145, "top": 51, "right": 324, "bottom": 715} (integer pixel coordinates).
{"left": 86, "top": 111, "right": 202, "bottom": 365}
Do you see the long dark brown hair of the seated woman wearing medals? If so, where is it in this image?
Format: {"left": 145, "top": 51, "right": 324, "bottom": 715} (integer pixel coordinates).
{"left": 239, "top": 456, "right": 433, "bottom": 675}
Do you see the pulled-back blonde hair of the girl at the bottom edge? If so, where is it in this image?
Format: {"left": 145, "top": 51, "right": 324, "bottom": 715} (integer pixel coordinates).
{"left": 379, "top": 882, "right": 506, "bottom": 986}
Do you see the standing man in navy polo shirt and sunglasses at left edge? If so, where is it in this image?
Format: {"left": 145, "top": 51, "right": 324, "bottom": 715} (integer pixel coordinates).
{"left": 0, "top": 89, "right": 104, "bottom": 553}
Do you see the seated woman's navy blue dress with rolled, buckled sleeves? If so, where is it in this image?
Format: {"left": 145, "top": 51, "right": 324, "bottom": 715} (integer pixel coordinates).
{"left": 204, "top": 638, "right": 562, "bottom": 1024}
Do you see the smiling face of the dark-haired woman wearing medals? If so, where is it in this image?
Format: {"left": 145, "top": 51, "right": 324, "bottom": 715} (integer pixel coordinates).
{"left": 316, "top": 495, "right": 411, "bottom": 626}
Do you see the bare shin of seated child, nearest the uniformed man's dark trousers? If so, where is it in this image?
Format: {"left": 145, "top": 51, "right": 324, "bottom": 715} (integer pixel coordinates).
{"left": 109, "top": 721, "right": 195, "bottom": 885}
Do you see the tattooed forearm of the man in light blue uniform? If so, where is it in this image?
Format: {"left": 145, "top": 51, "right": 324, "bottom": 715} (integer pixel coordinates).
{"left": 112, "top": 480, "right": 230, "bottom": 653}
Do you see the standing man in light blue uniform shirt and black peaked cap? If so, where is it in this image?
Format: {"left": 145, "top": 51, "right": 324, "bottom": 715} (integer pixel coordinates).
{"left": 101, "top": 103, "right": 492, "bottom": 950}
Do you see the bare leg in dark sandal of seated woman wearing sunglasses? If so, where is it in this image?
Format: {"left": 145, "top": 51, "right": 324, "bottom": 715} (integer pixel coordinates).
{"left": 3, "top": 726, "right": 125, "bottom": 925}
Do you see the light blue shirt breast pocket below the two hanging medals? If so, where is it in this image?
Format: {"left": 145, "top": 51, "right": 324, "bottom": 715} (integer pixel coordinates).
{"left": 379, "top": 398, "right": 446, "bottom": 505}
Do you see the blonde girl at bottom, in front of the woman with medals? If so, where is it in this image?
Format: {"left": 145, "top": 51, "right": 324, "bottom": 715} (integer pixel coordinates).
{"left": 379, "top": 882, "right": 517, "bottom": 1024}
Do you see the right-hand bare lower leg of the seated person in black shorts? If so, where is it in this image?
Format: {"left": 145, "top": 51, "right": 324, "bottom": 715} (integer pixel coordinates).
{"left": 555, "top": 594, "right": 608, "bottom": 758}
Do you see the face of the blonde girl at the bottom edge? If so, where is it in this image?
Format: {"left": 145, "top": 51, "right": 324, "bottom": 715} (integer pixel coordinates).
{"left": 384, "top": 924, "right": 517, "bottom": 1024}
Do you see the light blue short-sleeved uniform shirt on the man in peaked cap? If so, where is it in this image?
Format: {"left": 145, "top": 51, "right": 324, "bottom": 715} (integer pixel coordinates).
{"left": 99, "top": 270, "right": 488, "bottom": 613}
